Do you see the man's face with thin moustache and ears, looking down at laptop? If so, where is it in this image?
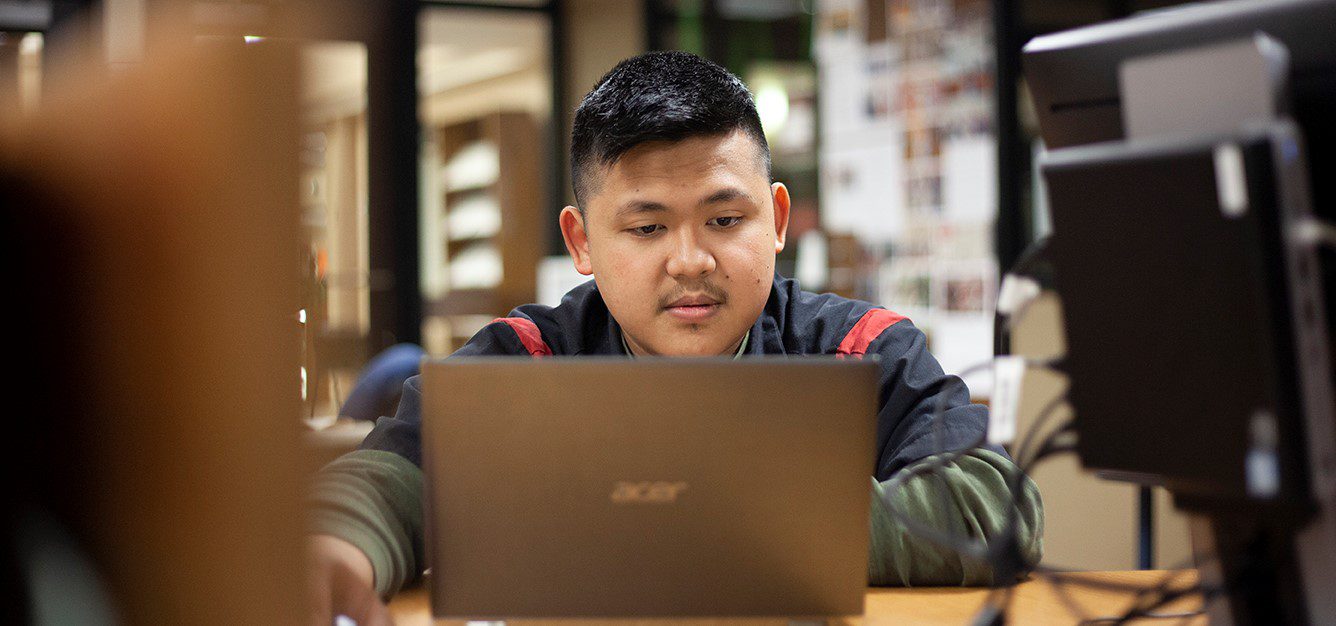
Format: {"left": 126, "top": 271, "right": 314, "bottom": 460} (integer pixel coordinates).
{"left": 561, "top": 131, "right": 788, "bottom": 356}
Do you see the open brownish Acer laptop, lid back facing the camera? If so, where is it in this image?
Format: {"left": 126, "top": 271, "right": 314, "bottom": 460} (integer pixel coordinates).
{"left": 422, "top": 356, "right": 878, "bottom": 621}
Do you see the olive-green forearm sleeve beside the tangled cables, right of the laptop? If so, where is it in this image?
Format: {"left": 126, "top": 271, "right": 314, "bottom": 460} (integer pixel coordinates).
{"left": 867, "top": 448, "right": 1043, "bottom": 586}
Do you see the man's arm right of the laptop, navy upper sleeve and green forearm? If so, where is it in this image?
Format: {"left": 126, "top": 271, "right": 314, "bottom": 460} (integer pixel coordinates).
{"left": 867, "top": 319, "right": 1043, "bottom": 585}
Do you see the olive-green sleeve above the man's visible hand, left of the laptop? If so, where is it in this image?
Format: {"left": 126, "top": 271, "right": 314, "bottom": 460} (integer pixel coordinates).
{"left": 310, "top": 450, "right": 426, "bottom": 598}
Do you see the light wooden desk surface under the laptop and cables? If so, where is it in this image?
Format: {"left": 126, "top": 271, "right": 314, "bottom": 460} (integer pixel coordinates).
{"left": 390, "top": 570, "right": 1206, "bottom": 626}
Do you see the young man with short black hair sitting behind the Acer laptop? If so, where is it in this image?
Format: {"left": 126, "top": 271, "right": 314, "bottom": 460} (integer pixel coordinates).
{"left": 311, "top": 52, "right": 1043, "bottom": 623}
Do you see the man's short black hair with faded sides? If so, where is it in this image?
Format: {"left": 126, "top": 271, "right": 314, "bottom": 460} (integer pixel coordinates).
{"left": 570, "top": 51, "right": 771, "bottom": 214}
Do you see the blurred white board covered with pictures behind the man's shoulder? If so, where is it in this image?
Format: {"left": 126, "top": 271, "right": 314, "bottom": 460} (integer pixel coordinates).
{"left": 814, "top": 0, "right": 998, "bottom": 398}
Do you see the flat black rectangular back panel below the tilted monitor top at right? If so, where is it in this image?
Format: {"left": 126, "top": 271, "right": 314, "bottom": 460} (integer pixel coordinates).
{"left": 1043, "top": 128, "right": 1313, "bottom": 501}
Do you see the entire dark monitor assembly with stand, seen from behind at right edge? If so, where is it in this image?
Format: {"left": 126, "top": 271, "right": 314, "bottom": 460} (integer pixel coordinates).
{"left": 1023, "top": 0, "right": 1336, "bottom": 623}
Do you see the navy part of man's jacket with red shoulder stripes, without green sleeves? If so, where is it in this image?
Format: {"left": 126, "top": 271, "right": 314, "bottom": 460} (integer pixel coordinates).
{"left": 361, "top": 274, "right": 1005, "bottom": 481}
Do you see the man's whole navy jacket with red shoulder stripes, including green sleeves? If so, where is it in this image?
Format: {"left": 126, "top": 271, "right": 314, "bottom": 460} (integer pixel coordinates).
{"left": 311, "top": 275, "right": 1043, "bottom": 595}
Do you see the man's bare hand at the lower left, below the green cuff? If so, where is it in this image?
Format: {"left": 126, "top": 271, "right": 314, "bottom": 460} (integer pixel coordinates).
{"left": 306, "top": 535, "right": 394, "bottom": 626}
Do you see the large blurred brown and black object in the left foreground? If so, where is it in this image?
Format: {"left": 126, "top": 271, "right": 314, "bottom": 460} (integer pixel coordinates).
{"left": 0, "top": 22, "right": 306, "bottom": 625}
